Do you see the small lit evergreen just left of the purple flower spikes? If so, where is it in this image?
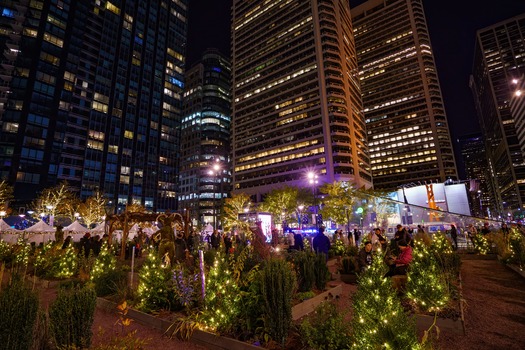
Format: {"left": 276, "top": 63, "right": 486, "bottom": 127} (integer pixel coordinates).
{"left": 137, "top": 252, "right": 171, "bottom": 310}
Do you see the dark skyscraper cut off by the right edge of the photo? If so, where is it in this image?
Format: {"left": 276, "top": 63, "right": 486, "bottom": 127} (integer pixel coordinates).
{"left": 470, "top": 14, "right": 525, "bottom": 218}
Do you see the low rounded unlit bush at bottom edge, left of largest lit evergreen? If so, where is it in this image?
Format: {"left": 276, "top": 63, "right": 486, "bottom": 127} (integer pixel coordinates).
{"left": 300, "top": 301, "right": 352, "bottom": 350}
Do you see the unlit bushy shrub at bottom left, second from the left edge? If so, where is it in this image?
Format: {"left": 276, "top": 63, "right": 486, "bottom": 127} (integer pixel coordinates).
{"left": 49, "top": 287, "right": 97, "bottom": 349}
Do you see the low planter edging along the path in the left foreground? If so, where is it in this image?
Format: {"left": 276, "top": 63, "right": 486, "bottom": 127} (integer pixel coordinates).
{"left": 97, "top": 298, "right": 264, "bottom": 350}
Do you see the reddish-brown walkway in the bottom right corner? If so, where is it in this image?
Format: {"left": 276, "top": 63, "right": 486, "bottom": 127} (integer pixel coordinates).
{"left": 439, "top": 255, "right": 525, "bottom": 350}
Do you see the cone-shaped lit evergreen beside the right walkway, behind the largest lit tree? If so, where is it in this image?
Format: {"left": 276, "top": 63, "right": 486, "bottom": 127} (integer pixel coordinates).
{"left": 406, "top": 241, "right": 449, "bottom": 311}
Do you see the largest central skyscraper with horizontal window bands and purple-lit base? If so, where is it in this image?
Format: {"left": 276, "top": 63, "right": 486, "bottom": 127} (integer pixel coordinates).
{"left": 232, "top": 0, "right": 371, "bottom": 200}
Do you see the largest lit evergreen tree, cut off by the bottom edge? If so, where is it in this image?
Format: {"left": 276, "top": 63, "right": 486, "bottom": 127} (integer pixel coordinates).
{"left": 352, "top": 255, "right": 420, "bottom": 350}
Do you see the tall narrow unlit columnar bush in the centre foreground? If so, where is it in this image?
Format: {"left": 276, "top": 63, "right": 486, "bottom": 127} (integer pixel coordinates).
{"left": 260, "top": 259, "right": 297, "bottom": 346}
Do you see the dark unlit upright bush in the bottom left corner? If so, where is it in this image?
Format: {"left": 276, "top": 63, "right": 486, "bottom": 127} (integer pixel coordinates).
{"left": 0, "top": 276, "right": 38, "bottom": 350}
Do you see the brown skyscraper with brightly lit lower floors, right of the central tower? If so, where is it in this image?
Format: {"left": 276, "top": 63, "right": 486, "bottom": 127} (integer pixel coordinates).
{"left": 352, "top": 0, "right": 457, "bottom": 189}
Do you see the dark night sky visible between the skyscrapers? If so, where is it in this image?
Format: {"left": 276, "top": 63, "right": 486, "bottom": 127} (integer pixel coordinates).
{"left": 187, "top": 0, "right": 525, "bottom": 174}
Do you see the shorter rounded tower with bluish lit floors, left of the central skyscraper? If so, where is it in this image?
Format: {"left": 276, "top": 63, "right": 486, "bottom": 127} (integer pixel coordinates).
{"left": 178, "top": 49, "right": 231, "bottom": 225}
